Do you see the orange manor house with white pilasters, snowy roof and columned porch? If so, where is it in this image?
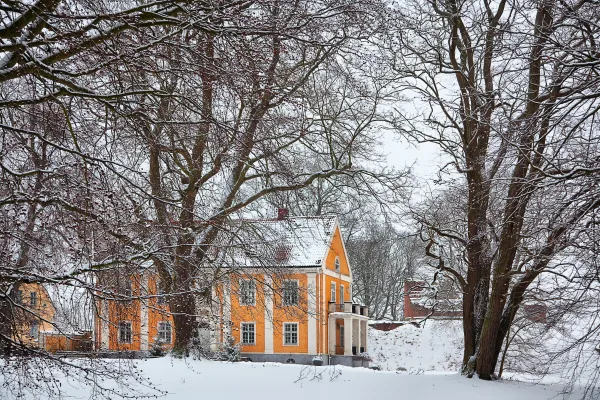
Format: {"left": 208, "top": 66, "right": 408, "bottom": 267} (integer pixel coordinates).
{"left": 96, "top": 214, "right": 369, "bottom": 366}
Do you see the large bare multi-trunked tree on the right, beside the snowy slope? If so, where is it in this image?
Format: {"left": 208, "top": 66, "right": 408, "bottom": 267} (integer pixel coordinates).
{"left": 382, "top": 0, "right": 600, "bottom": 379}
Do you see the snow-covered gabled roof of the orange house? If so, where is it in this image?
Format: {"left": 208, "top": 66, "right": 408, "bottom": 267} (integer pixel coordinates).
{"left": 216, "top": 215, "right": 337, "bottom": 267}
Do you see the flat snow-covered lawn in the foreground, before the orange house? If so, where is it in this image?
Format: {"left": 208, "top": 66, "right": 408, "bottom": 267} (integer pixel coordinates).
{"left": 51, "top": 357, "right": 578, "bottom": 400}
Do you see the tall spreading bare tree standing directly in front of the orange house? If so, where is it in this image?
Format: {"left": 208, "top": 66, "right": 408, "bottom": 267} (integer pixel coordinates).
{"left": 99, "top": 1, "right": 408, "bottom": 352}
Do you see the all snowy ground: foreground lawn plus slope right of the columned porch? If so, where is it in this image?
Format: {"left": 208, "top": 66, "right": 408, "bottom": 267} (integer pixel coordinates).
{"left": 0, "top": 321, "right": 583, "bottom": 400}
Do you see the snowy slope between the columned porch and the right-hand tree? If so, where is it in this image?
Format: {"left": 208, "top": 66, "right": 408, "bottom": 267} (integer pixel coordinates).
{"left": 369, "top": 320, "right": 462, "bottom": 373}
